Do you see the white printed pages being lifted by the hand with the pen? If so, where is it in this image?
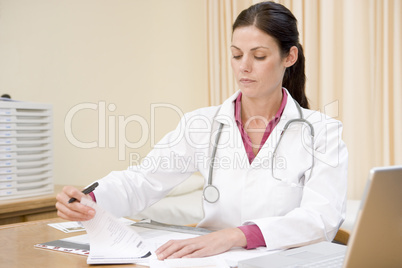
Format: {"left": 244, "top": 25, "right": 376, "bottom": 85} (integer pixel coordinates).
{"left": 81, "top": 198, "right": 155, "bottom": 264}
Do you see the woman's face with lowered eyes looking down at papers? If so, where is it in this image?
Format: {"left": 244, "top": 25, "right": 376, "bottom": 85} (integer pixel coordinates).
{"left": 231, "top": 26, "right": 297, "bottom": 98}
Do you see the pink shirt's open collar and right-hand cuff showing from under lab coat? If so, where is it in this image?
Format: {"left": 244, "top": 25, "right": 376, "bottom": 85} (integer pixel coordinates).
{"left": 235, "top": 89, "right": 288, "bottom": 249}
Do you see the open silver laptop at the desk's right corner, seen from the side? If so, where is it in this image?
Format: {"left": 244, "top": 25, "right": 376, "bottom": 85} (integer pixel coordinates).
{"left": 238, "top": 166, "right": 402, "bottom": 268}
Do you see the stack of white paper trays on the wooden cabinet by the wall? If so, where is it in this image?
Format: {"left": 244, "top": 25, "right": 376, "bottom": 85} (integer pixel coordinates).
{"left": 0, "top": 101, "right": 53, "bottom": 200}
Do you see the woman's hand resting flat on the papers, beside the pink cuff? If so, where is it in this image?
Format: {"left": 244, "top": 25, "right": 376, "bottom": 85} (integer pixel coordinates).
{"left": 155, "top": 228, "right": 247, "bottom": 260}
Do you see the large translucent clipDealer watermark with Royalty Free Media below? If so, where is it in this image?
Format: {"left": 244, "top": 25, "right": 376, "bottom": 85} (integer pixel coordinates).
{"left": 64, "top": 101, "right": 341, "bottom": 170}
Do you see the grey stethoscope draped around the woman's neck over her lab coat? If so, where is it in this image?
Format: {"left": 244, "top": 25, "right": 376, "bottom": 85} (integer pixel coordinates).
{"left": 203, "top": 101, "right": 314, "bottom": 203}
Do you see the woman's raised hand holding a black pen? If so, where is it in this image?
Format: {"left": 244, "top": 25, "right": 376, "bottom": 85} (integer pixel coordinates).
{"left": 56, "top": 186, "right": 95, "bottom": 221}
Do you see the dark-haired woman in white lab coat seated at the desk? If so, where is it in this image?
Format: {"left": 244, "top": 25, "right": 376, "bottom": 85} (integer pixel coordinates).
{"left": 56, "top": 2, "right": 347, "bottom": 259}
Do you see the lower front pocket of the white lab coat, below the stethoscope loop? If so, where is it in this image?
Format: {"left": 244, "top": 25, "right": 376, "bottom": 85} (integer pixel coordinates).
{"left": 274, "top": 183, "right": 303, "bottom": 216}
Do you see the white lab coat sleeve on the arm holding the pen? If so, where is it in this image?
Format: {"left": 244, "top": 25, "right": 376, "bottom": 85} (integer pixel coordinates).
{"left": 94, "top": 112, "right": 203, "bottom": 217}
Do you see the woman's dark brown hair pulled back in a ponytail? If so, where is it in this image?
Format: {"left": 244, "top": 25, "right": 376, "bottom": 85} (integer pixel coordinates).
{"left": 232, "top": 2, "right": 309, "bottom": 108}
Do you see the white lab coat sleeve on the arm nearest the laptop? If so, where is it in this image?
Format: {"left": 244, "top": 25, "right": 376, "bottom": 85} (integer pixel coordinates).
{"left": 244, "top": 116, "right": 348, "bottom": 249}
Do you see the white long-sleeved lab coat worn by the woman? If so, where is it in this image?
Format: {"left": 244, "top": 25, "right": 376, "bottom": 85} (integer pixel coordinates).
{"left": 94, "top": 89, "right": 348, "bottom": 249}
